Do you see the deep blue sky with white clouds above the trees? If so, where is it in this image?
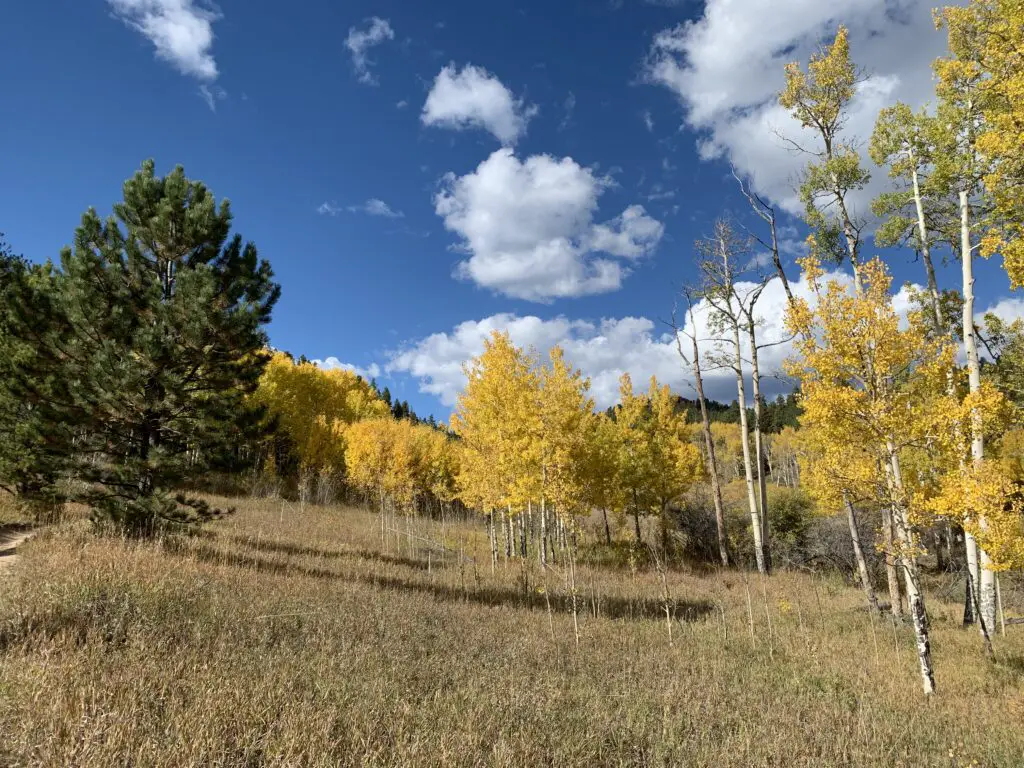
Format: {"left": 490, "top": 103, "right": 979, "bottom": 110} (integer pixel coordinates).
{"left": 0, "top": 0, "right": 1021, "bottom": 417}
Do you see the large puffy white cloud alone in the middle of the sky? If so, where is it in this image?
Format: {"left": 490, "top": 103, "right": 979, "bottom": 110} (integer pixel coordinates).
{"left": 434, "top": 148, "right": 664, "bottom": 301}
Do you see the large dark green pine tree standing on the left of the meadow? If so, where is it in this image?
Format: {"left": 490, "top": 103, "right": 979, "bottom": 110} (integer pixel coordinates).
{"left": 11, "top": 161, "right": 280, "bottom": 532}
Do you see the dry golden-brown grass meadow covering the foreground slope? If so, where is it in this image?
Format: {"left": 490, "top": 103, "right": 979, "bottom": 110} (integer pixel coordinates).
{"left": 0, "top": 501, "right": 1024, "bottom": 768}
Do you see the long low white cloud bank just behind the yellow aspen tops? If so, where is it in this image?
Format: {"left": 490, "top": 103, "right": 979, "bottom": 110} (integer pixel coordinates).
{"left": 386, "top": 272, "right": 856, "bottom": 409}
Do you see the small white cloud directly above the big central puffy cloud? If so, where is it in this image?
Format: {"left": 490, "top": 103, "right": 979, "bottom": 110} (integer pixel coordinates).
{"left": 420, "top": 65, "right": 538, "bottom": 145}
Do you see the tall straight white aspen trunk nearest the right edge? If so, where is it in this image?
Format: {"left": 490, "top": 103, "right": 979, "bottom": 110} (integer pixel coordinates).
{"left": 959, "top": 189, "right": 995, "bottom": 632}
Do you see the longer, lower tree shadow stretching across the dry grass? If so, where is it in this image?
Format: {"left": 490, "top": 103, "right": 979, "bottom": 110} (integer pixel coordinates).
{"left": 166, "top": 539, "right": 715, "bottom": 622}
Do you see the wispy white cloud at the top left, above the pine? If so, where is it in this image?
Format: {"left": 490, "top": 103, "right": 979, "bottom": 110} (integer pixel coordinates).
{"left": 106, "top": 0, "right": 221, "bottom": 82}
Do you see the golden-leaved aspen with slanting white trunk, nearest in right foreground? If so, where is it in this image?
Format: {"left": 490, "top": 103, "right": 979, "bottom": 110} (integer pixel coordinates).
{"left": 786, "top": 254, "right": 959, "bottom": 694}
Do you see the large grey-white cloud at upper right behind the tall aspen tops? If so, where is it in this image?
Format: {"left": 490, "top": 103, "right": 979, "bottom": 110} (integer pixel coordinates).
{"left": 646, "top": 0, "right": 958, "bottom": 215}
